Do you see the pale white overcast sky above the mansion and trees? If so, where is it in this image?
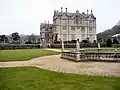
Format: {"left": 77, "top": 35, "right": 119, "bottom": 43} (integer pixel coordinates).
{"left": 0, "top": 0, "right": 120, "bottom": 35}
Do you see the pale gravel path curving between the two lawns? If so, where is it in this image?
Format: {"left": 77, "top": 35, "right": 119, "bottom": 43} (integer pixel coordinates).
{"left": 0, "top": 55, "right": 120, "bottom": 77}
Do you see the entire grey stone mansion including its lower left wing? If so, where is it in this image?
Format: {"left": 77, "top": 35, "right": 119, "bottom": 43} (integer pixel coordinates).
{"left": 40, "top": 7, "right": 96, "bottom": 44}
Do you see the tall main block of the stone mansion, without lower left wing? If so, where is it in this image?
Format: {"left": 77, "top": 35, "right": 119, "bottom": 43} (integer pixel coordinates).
{"left": 52, "top": 8, "right": 96, "bottom": 42}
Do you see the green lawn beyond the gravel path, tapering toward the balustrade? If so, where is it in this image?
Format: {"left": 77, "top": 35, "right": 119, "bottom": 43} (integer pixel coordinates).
{"left": 0, "top": 49, "right": 59, "bottom": 61}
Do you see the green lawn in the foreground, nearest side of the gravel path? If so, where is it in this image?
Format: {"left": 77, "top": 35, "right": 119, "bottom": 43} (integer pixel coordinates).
{"left": 0, "top": 67, "right": 120, "bottom": 90}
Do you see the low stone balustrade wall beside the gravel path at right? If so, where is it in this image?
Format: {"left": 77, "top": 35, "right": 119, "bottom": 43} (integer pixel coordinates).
{"left": 61, "top": 52, "right": 120, "bottom": 62}
